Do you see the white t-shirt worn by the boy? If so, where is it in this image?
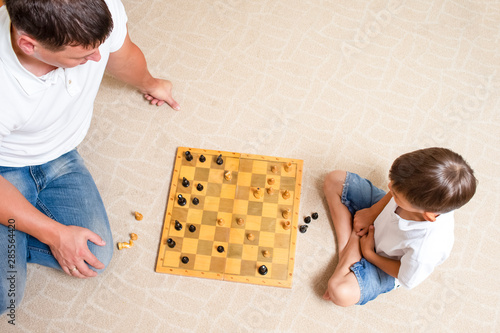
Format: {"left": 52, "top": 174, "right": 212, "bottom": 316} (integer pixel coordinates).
{"left": 374, "top": 198, "right": 454, "bottom": 289}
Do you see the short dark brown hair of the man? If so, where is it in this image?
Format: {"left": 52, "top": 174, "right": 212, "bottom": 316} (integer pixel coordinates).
{"left": 4, "top": 0, "right": 113, "bottom": 51}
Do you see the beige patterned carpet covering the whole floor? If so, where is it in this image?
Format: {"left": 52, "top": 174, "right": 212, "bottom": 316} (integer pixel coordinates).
{"left": 0, "top": 0, "right": 500, "bottom": 332}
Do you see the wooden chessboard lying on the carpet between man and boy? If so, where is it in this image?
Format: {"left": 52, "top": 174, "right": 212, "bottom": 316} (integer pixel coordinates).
{"left": 156, "top": 147, "right": 303, "bottom": 288}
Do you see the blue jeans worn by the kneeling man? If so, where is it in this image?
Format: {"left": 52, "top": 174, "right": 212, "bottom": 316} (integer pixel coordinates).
{"left": 0, "top": 150, "right": 113, "bottom": 313}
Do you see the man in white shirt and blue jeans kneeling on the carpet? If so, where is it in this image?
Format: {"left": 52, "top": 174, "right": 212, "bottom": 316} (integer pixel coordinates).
{"left": 0, "top": 0, "right": 179, "bottom": 313}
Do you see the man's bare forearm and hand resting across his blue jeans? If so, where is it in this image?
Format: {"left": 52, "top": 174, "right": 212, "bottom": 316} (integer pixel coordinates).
{"left": 0, "top": 176, "right": 105, "bottom": 278}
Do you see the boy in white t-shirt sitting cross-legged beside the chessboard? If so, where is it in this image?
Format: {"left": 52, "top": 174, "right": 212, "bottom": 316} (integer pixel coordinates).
{"left": 323, "top": 148, "right": 477, "bottom": 306}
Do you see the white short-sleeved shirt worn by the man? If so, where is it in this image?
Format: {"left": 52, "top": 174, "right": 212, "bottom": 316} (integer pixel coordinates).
{"left": 0, "top": 0, "right": 127, "bottom": 167}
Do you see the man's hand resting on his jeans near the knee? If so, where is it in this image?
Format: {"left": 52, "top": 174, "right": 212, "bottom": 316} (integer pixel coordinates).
{"left": 49, "top": 225, "right": 106, "bottom": 278}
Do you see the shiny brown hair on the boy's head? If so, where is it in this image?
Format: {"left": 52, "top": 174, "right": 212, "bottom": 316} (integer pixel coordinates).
{"left": 389, "top": 147, "right": 477, "bottom": 214}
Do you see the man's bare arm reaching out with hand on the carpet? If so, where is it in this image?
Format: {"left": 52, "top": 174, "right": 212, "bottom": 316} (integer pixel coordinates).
{"left": 106, "top": 29, "right": 180, "bottom": 110}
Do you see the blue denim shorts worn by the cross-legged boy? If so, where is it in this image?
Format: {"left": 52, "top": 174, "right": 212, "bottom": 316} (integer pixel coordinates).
{"left": 342, "top": 172, "right": 396, "bottom": 305}
